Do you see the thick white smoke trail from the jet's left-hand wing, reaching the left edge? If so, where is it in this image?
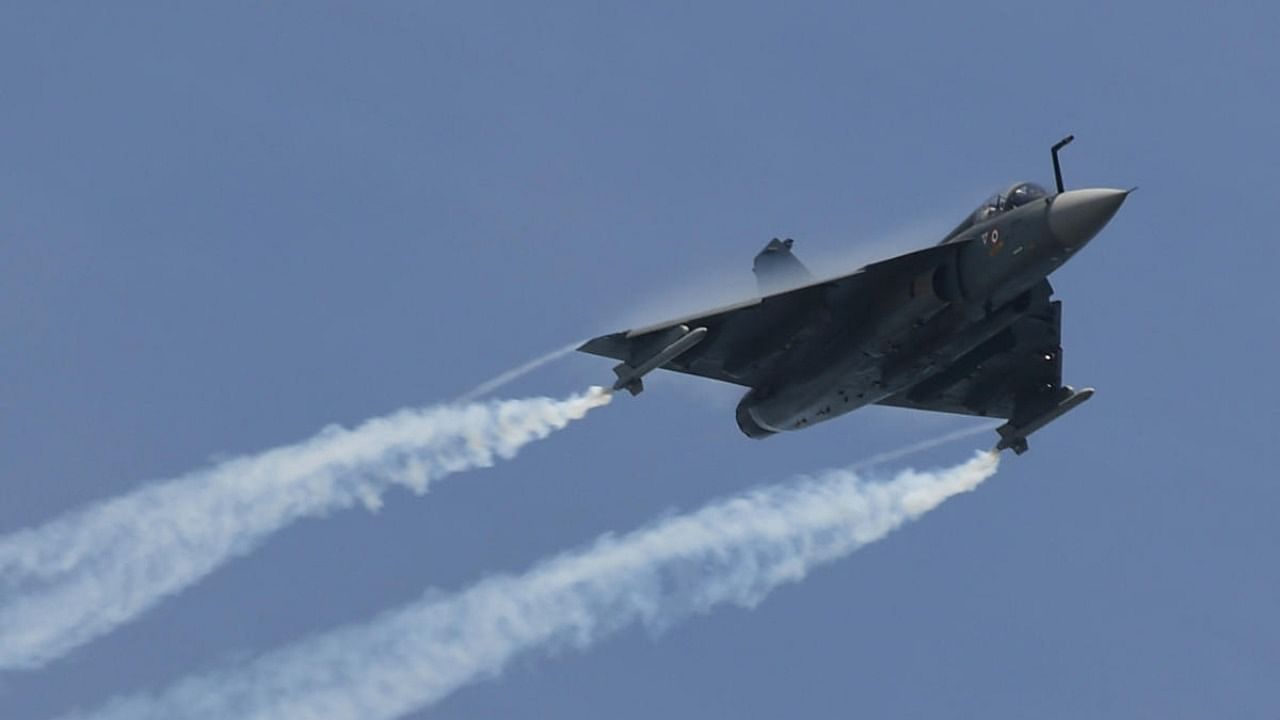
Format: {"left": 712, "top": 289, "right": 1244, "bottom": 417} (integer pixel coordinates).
{"left": 0, "top": 388, "right": 611, "bottom": 669}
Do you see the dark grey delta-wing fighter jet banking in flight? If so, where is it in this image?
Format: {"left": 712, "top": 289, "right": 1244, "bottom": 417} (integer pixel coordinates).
{"left": 579, "top": 136, "right": 1132, "bottom": 455}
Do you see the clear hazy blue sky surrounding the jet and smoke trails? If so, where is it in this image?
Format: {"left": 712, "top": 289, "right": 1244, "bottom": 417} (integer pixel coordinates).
{"left": 0, "top": 3, "right": 1280, "bottom": 719}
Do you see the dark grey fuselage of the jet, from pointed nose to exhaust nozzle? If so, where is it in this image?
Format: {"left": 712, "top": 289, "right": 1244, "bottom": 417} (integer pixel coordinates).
{"left": 737, "top": 188, "right": 1125, "bottom": 437}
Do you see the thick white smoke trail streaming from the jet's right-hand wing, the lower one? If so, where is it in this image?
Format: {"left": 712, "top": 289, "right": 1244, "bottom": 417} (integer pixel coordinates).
{"left": 60, "top": 452, "right": 998, "bottom": 720}
